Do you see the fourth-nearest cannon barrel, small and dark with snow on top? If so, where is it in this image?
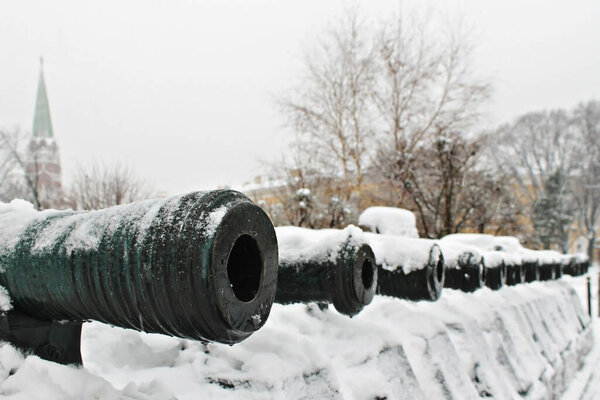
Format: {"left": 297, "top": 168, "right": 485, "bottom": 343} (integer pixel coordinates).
{"left": 438, "top": 240, "right": 485, "bottom": 292}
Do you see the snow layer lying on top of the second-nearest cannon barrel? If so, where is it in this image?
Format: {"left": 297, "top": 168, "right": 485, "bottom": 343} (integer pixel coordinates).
{"left": 275, "top": 225, "right": 366, "bottom": 265}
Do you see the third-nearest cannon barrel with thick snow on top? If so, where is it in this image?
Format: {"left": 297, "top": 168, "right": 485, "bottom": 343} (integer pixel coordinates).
{"left": 365, "top": 233, "right": 446, "bottom": 301}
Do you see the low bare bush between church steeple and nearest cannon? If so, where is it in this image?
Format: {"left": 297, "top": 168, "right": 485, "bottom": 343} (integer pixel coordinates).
{"left": 71, "top": 164, "right": 152, "bottom": 210}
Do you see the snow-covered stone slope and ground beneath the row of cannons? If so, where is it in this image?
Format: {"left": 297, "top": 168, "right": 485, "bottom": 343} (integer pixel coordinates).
{"left": 0, "top": 274, "right": 600, "bottom": 400}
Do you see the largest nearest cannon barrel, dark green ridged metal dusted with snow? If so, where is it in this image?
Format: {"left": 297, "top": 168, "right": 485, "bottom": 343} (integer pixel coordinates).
{"left": 0, "top": 190, "right": 277, "bottom": 344}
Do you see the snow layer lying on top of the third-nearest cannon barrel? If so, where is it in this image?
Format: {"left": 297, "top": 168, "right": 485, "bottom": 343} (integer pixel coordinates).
{"left": 364, "top": 232, "right": 437, "bottom": 274}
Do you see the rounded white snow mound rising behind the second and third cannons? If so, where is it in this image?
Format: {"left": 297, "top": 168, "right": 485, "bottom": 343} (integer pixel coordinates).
{"left": 358, "top": 207, "right": 419, "bottom": 238}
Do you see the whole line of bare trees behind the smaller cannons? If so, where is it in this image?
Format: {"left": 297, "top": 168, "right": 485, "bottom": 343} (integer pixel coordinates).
{"left": 258, "top": 11, "right": 600, "bottom": 262}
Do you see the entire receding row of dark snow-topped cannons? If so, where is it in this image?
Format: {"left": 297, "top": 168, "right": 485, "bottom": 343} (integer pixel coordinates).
{"left": 0, "top": 190, "right": 589, "bottom": 364}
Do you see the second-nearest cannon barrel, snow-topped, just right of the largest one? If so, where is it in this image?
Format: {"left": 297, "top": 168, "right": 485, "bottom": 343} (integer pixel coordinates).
{"left": 275, "top": 226, "right": 377, "bottom": 316}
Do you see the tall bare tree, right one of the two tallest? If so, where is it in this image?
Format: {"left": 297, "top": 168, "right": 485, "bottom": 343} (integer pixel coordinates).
{"left": 373, "top": 10, "right": 491, "bottom": 190}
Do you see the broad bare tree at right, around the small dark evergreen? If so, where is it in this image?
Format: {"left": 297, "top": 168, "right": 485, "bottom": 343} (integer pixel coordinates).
{"left": 491, "top": 106, "right": 581, "bottom": 251}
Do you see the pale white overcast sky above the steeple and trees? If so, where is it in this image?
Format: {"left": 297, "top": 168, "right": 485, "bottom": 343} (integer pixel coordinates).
{"left": 0, "top": 0, "right": 600, "bottom": 194}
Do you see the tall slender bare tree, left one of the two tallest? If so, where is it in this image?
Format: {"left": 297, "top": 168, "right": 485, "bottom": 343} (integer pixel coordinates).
{"left": 279, "top": 7, "right": 374, "bottom": 208}
